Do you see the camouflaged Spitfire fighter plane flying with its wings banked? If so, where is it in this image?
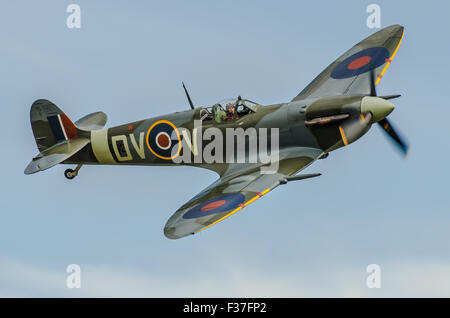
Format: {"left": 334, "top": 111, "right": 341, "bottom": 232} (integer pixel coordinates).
{"left": 25, "top": 25, "right": 409, "bottom": 239}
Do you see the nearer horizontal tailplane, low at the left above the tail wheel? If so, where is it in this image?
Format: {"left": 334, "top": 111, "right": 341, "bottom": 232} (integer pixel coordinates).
{"left": 24, "top": 138, "right": 90, "bottom": 174}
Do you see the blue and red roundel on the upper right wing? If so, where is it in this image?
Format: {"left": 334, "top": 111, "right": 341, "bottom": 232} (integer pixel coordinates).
{"left": 330, "top": 47, "right": 389, "bottom": 79}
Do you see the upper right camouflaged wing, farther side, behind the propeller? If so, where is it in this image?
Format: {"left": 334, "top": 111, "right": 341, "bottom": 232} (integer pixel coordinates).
{"left": 292, "top": 25, "right": 403, "bottom": 101}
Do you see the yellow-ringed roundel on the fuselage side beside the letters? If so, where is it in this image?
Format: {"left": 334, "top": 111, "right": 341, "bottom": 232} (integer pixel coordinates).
{"left": 147, "top": 120, "right": 181, "bottom": 160}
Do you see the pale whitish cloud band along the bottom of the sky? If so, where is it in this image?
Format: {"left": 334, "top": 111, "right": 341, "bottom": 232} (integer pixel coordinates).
{"left": 0, "top": 260, "right": 450, "bottom": 297}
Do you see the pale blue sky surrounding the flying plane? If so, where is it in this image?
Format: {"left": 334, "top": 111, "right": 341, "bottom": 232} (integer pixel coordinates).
{"left": 0, "top": 0, "right": 450, "bottom": 297}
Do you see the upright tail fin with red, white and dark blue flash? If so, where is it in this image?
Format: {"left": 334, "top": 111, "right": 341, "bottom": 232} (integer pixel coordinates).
{"left": 30, "top": 99, "right": 78, "bottom": 152}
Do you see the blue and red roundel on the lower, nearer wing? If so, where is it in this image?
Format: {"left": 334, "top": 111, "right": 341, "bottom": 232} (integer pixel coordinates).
{"left": 183, "top": 193, "right": 245, "bottom": 219}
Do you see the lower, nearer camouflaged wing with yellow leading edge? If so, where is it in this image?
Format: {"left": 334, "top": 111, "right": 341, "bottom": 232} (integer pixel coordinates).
{"left": 164, "top": 147, "right": 323, "bottom": 239}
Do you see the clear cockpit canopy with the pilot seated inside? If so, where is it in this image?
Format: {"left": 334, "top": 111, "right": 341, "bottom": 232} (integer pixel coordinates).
{"left": 200, "top": 96, "right": 261, "bottom": 123}
